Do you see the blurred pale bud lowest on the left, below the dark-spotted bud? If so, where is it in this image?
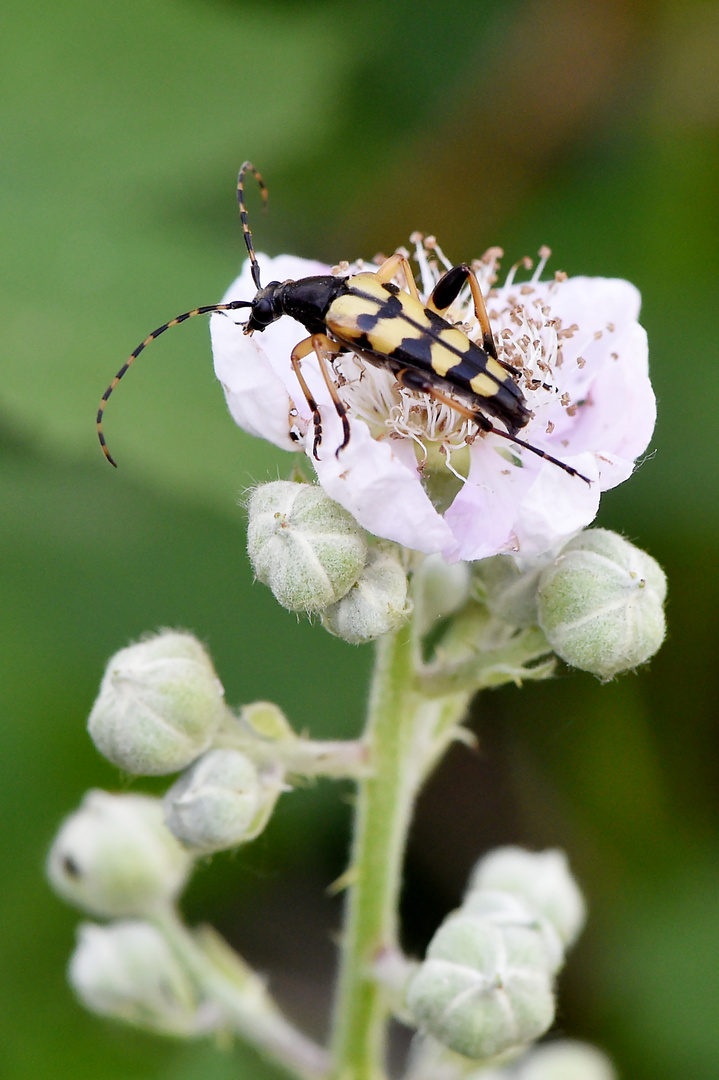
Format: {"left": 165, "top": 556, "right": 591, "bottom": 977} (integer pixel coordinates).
{"left": 68, "top": 920, "right": 219, "bottom": 1036}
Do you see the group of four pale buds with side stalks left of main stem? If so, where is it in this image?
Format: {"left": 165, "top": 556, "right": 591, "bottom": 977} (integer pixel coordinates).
{"left": 48, "top": 622, "right": 380, "bottom": 1053}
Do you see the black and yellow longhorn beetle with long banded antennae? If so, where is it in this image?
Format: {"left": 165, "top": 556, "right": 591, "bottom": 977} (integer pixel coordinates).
{"left": 97, "top": 161, "right": 589, "bottom": 483}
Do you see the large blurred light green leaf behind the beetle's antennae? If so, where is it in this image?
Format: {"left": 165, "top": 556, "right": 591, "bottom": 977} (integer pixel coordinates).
{"left": 0, "top": 0, "right": 345, "bottom": 505}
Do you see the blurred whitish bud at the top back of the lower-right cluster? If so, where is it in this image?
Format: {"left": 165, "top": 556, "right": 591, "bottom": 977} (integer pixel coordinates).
{"left": 465, "top": 848, "right": 585, "bottom": 948}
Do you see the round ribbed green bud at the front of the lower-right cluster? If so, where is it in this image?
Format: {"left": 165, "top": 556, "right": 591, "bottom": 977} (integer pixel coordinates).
{"left": 407, "top": 909, "right": 554, "bottom": 1061}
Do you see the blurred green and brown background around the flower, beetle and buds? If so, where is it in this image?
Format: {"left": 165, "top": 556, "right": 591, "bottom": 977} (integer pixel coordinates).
{"left": 0, "top": 0, "right": 719, "bottom": 1080}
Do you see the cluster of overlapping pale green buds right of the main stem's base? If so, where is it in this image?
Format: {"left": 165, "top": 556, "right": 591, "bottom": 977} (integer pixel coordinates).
{"left": 407, "top": 848, "right": 584, "bottom": 1061}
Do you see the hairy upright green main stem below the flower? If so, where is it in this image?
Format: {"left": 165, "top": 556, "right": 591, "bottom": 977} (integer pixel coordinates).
{"left": 333, "top": 626, "right": 467, "bottom": 1080}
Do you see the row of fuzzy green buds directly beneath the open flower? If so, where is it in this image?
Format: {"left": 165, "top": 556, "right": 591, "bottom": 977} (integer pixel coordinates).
{"left": 247, "top": 481, "right": 666, "bottom": 679}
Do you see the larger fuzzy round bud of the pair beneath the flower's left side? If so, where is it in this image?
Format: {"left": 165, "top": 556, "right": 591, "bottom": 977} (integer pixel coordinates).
{"left": 247, "top": 480, "right": 367, "bottom": 612}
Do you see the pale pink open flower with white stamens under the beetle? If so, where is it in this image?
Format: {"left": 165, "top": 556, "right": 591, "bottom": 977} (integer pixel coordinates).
{"left": 211, "top": 244, "right": 655, "bottom": 562}
